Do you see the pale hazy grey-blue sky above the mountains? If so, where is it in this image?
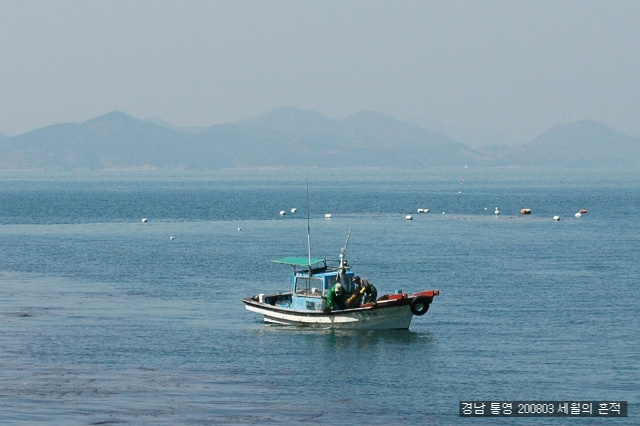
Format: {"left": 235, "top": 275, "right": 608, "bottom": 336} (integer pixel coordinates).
{"left": 0, "top": 0, "right": 640, "bottom": 143}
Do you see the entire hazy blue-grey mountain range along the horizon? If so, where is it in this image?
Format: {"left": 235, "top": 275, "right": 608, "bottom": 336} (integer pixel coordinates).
{"left": 0, "top": 107, "right": 640, "bottom": 170}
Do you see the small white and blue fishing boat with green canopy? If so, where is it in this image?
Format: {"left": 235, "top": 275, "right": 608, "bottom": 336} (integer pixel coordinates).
{"left": 242, "top": 231, "right": 440, "bottom": 330}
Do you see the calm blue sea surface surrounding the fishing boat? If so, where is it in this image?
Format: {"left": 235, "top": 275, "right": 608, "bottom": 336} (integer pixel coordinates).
{"left": 0, "top": 169, "right": 640, "bottom": 425}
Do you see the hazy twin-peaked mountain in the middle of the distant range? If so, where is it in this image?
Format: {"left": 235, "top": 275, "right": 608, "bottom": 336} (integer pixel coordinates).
{"left": 240, "top": 107, "right": 482, "bottom": 167}
